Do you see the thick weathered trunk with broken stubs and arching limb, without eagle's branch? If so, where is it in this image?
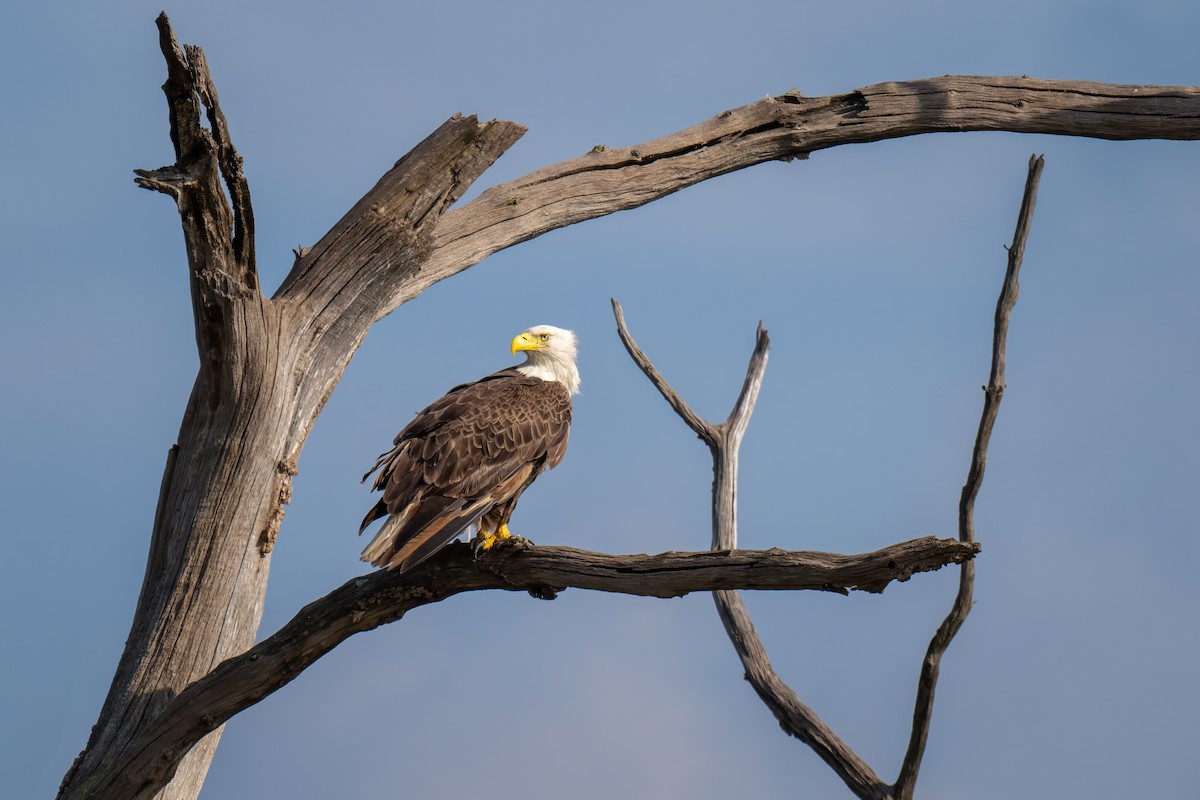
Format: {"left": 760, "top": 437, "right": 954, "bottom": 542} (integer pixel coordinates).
{"left": 60, "top": 10, "right": 1200, "bottom": 799}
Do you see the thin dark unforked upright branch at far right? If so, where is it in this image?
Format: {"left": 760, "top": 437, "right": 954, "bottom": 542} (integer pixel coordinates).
{"left": 895, "top": 155, "right": 1045, "bottom": 800}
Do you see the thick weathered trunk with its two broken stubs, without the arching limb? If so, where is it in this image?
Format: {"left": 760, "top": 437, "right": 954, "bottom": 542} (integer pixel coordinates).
{"left": 60, "top": 16, "right": 521, "bottom": 800}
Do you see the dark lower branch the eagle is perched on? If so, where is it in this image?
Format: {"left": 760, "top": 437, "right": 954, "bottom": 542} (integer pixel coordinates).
{"left": 88, "top": 536, "right": 979, "bottom": 800}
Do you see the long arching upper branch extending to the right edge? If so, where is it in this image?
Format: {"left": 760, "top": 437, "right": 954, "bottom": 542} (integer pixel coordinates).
{"left": 390, "top": 76, "right": 1200, "bottom": 309}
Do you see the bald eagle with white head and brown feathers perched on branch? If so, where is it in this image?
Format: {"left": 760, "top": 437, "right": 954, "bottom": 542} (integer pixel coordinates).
{"left": 359, "top": 325, "right": 580, "bottom": 572}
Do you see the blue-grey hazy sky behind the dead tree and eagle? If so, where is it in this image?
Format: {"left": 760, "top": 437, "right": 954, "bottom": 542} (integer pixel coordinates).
{"left": 0, "top": 0, "right": 1200, "bottom": 799}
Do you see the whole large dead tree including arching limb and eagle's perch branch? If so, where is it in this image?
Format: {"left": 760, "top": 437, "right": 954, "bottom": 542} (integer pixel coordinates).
{"left": 60, "top": 16, "right": 1200, "bottom": 799}
